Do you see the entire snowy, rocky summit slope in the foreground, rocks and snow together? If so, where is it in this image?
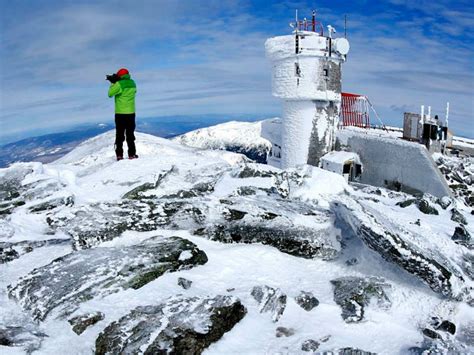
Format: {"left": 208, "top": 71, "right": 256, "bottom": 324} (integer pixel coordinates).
{"left": 0, "top": 131, "right": 474, "bottom": 354}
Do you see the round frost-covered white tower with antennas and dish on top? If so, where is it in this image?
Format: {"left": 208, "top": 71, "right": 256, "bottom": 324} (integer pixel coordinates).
{"left": 265, "top": 12, "right": 349, "bottom": 169}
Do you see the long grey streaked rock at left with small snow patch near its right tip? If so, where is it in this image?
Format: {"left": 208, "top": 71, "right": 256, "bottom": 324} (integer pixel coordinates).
{"left": 8, "top": 236, "right": 207, "bottom": 320}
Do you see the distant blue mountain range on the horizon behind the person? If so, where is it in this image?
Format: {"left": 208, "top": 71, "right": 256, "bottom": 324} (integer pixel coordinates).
{"left": 0, "top": 116, "right": 260, "bottom": 168}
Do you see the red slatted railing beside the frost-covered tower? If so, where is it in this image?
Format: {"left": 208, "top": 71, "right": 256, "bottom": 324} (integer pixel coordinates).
{"left": 340, "top": 92, "right": 370, "bottom": 128}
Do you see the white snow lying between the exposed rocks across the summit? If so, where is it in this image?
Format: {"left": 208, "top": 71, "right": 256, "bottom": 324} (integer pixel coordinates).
{"left": 0, "top": 127, "right": 474, "bottom": 355}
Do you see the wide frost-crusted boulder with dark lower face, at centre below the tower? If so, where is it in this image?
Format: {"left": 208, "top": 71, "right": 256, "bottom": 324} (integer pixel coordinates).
{"left": 194, "top": 196, "right": 341, "bottom": 260}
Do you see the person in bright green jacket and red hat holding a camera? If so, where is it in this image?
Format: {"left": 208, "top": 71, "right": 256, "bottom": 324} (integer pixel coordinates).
{"left": 109, "top": 68, "right": 138, "bottom": 160}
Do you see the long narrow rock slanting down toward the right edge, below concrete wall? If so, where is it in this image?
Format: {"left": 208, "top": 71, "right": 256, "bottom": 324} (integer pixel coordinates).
{"left": 334, "top": 200, "right": 464, "bottom": 299}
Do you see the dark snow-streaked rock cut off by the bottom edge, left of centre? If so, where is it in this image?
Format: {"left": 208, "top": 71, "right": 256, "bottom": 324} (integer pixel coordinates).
{"left": 95, "top": 296, "right": 246, "bottom": 355}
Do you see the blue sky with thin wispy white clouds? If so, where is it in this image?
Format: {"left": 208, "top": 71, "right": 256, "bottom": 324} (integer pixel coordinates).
{"left": 0, "top": 0, "right": 474, "bottom": 142}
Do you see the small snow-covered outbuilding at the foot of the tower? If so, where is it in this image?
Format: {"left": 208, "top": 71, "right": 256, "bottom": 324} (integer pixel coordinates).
{"left": 321, "top": 151, "right": 362, "bottom": 182}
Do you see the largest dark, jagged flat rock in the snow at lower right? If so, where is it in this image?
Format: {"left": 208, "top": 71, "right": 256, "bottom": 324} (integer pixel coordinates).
{"left": 331, "top": 277, "right": 391, "bottom": 323}
